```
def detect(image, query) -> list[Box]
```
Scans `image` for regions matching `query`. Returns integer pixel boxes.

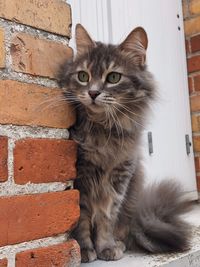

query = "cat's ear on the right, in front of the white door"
[119,27,148,65]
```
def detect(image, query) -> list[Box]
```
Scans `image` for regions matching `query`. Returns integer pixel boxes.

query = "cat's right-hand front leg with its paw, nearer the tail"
[95,162,133,260]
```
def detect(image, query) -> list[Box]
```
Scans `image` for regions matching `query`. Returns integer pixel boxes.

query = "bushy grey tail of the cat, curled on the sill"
[132,181,191,253]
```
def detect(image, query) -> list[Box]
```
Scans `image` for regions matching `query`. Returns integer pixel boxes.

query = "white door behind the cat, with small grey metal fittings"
[68,0,197,199]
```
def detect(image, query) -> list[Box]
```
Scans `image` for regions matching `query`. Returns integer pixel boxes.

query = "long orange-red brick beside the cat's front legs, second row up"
[0,190,79,246]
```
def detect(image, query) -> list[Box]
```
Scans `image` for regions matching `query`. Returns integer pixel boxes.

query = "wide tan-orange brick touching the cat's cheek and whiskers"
[0,80,75,128]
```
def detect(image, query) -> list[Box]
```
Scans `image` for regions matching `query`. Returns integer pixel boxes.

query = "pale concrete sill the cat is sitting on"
[81,204,200,267]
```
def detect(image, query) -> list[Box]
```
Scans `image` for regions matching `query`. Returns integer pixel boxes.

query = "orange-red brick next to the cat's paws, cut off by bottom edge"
[15,240,80,267]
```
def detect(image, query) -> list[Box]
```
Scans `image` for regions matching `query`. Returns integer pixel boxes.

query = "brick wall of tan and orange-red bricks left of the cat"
[0,0,80,267]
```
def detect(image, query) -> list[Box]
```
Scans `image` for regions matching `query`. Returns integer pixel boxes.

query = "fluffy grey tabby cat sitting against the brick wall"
[59,24,190,262]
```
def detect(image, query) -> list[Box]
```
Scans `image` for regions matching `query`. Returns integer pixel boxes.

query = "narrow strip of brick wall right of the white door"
[183,0,200,192]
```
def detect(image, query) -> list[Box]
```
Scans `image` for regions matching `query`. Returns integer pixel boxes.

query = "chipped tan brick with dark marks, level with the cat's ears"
[11,33,72,78]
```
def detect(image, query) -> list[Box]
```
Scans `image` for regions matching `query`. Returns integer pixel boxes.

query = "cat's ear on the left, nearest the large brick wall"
[76,24,95,54]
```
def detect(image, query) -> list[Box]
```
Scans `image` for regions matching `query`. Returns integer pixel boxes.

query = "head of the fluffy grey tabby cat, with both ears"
[58,24,154,124]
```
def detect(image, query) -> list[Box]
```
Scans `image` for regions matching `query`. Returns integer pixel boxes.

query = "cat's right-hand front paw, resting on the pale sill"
[97,246,124,261]
